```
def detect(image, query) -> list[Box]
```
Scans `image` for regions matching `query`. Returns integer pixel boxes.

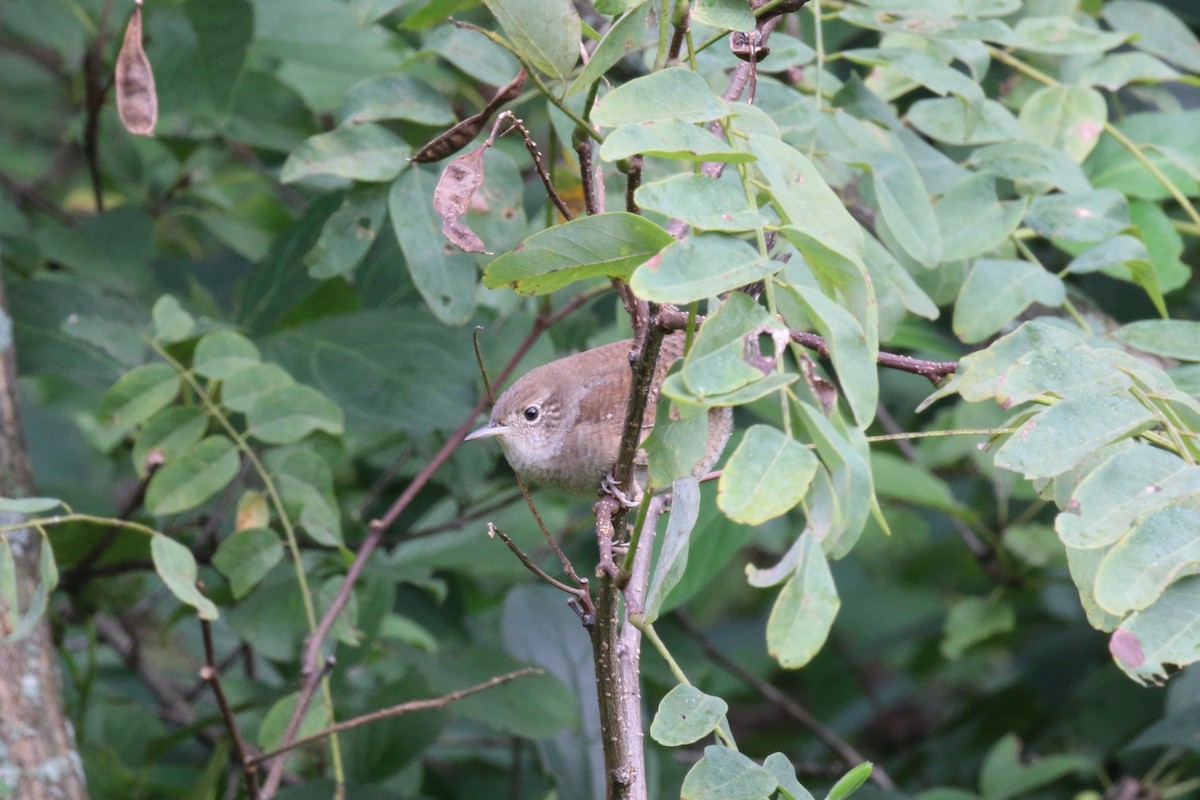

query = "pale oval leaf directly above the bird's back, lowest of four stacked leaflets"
[629,234,782,306]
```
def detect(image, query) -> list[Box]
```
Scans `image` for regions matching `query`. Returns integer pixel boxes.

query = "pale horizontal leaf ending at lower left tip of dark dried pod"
[280,122,413,184]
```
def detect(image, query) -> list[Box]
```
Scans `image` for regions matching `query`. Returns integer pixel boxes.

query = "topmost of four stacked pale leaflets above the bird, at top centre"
[592,67,731,128]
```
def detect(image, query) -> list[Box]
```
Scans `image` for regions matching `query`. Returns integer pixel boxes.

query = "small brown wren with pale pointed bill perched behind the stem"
[467,333,732,494]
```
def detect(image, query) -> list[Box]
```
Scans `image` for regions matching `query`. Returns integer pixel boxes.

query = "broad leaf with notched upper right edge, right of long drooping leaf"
[934,173,1027,261]
